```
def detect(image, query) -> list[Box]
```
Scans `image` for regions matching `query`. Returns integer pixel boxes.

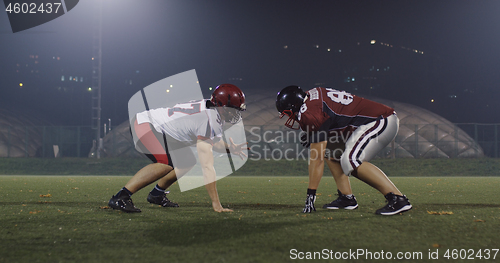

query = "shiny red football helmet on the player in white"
[210,84,246,124]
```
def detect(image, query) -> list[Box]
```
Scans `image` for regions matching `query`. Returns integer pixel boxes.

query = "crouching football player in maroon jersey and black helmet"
[276,86,412,215]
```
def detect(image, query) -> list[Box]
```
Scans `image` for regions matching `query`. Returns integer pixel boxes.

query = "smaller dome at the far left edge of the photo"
[0,109,48,157]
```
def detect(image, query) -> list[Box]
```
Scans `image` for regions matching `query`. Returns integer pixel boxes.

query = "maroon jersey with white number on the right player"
[298,88,394,131]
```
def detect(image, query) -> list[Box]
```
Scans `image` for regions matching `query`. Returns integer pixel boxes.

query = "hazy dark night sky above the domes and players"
[0,0,500,125]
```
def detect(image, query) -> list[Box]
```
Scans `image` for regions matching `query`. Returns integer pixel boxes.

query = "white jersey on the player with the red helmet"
[137,100,223,145]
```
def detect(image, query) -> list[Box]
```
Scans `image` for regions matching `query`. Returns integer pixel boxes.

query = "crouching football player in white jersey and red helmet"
[108,84,247,212]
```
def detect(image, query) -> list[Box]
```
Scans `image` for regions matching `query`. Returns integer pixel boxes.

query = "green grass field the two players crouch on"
[0,176,500,262]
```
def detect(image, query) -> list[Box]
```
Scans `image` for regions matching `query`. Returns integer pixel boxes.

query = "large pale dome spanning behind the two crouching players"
[100,93,484,158]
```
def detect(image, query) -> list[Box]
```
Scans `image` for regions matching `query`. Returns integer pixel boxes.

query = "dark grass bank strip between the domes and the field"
[0,158,500,177]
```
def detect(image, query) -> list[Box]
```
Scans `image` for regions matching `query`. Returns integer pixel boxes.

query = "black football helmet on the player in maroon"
[276,86,306,130]
